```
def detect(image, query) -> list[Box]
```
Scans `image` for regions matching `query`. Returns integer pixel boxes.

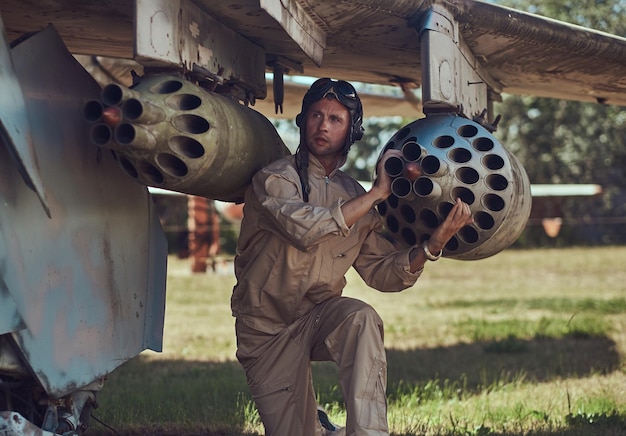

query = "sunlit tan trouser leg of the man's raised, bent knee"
[312,297,389,436]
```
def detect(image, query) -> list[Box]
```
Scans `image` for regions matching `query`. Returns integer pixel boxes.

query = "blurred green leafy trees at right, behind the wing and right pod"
[496,0,626,244]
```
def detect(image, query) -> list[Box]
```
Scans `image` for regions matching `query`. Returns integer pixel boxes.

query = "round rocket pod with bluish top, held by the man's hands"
[378,114,532,260]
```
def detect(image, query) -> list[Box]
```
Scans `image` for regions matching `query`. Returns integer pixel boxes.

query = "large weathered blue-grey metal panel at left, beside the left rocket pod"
[0,28,167,397]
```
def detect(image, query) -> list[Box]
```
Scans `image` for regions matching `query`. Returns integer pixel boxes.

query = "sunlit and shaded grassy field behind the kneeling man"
[89,247,626,436]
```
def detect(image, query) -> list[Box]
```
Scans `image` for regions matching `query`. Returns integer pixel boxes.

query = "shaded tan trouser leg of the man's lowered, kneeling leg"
[236,322,322,436]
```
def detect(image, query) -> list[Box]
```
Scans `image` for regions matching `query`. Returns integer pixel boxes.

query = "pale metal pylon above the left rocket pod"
[135,0,267,101]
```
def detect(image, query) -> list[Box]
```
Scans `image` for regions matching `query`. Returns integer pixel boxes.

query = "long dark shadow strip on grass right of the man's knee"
[387,336,620,392]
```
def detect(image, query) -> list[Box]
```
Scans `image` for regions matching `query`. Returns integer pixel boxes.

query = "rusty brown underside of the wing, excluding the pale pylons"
[0,0,626,105]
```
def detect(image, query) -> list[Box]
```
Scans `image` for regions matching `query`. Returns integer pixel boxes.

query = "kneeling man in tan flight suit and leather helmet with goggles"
[232,79,472,436]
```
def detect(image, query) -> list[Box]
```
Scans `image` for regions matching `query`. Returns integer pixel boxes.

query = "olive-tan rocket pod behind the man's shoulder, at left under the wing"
[83,74,290,202]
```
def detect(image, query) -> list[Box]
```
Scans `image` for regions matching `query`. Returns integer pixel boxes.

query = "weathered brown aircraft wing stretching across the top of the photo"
[0,0,626,115]
